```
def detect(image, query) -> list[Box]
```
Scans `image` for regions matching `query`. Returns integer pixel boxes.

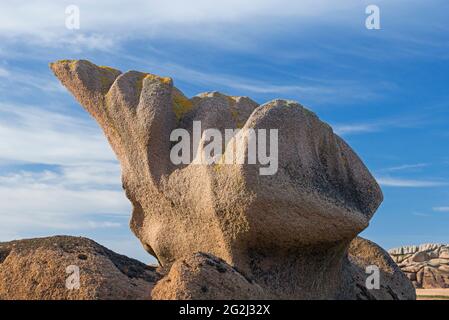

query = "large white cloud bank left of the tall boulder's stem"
[0,104,131,234]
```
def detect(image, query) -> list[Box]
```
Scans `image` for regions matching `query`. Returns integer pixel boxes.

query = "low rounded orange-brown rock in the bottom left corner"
[0,236,160,300]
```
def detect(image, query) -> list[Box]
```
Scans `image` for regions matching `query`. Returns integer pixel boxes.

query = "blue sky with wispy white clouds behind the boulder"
[0,0,449,261]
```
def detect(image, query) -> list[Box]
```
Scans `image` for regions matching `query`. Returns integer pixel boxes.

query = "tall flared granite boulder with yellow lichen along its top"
[51,60,414,299]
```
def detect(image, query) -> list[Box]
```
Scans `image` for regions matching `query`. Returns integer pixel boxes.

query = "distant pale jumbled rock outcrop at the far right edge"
[388,244,449,289]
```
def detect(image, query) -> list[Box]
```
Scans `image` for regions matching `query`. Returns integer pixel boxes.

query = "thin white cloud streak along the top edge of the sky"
[0,0,355,34]
